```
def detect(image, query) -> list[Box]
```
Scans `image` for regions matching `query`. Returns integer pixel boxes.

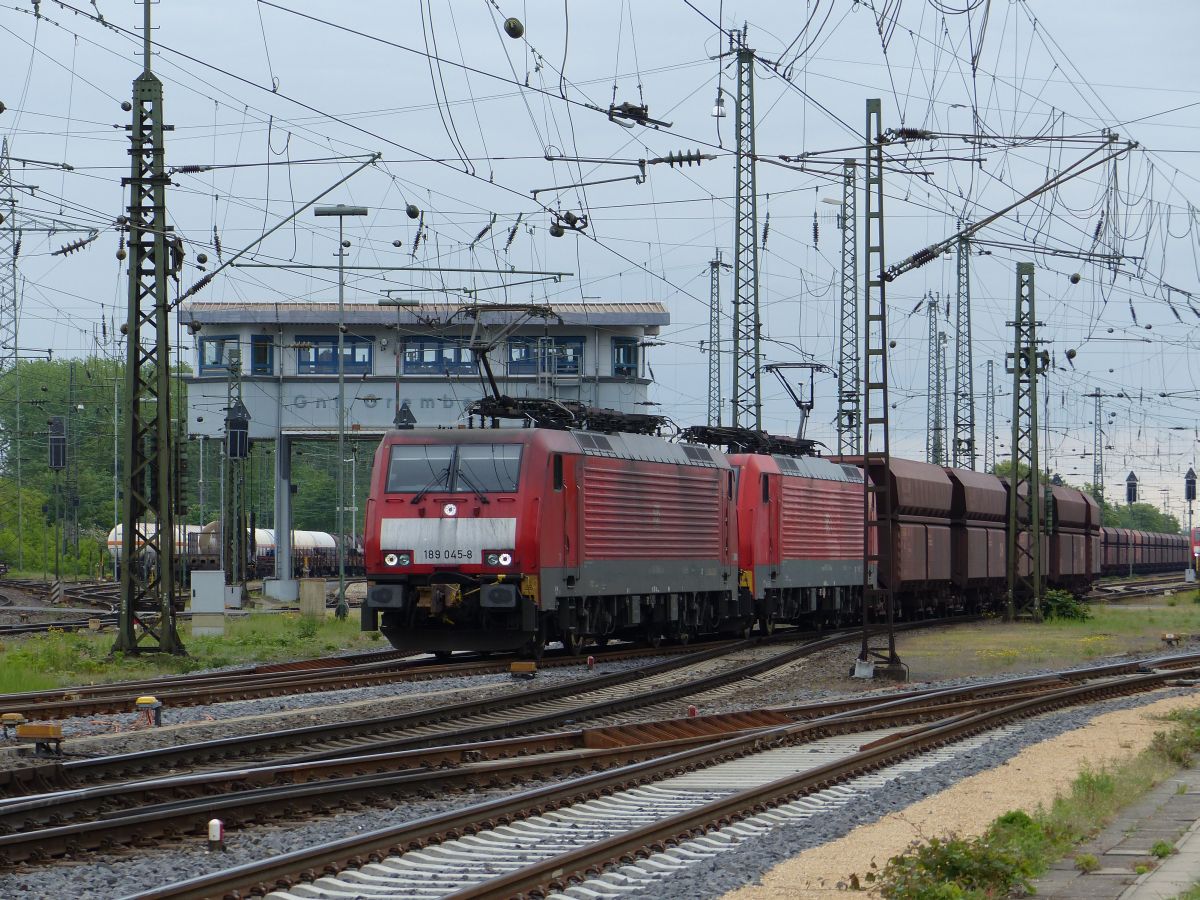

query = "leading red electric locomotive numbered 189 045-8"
[362,428,754,655]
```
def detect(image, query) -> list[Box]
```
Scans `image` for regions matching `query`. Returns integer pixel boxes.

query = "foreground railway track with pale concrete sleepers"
[124,656,1200,900]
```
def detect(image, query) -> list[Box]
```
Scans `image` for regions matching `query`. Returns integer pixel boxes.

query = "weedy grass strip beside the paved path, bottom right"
[851,709,1200,900]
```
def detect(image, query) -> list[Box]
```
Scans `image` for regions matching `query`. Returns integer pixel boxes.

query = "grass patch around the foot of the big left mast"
[0,613,378,694]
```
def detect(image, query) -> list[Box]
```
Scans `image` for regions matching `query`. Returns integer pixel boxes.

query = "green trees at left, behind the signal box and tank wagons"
[0,356,374,576]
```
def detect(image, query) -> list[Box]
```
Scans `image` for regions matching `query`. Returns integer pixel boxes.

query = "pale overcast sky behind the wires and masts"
[0,0,1200,512]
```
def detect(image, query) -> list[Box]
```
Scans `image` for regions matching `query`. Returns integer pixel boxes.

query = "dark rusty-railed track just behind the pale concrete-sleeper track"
[0,677,1080,864]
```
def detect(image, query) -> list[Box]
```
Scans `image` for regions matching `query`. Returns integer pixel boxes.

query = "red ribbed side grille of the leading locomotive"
[582,466,722,559]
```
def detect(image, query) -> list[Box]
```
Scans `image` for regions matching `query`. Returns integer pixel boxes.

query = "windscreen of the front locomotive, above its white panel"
[386,444,521,493]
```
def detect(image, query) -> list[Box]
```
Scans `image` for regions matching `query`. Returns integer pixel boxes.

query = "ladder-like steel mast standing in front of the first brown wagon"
[858,98,901,673]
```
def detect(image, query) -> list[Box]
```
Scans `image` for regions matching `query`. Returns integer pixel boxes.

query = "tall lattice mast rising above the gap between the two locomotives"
[731,30,762,430]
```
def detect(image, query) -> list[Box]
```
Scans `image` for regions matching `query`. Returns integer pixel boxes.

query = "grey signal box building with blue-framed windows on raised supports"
[180,301,670,599]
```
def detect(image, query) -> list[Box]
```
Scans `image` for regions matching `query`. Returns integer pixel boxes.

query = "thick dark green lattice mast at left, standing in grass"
[113,0,184,653]
